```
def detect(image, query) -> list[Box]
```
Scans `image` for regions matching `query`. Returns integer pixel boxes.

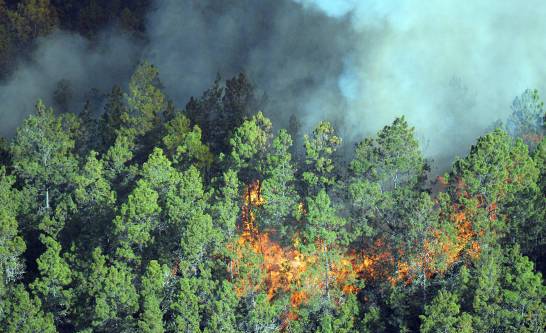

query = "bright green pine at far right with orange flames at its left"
[451,129,542,248]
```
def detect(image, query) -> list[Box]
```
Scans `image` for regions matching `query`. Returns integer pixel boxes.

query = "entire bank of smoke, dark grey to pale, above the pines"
[0,0,546,166]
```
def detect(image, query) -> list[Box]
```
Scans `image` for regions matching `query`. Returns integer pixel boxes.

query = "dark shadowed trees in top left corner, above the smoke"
[0,0,150,78]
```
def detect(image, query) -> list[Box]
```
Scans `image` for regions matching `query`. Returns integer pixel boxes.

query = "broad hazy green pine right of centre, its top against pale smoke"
[348,117,428,260]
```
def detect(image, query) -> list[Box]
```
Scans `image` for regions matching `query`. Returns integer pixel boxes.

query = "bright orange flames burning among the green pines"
[231,180,484,312]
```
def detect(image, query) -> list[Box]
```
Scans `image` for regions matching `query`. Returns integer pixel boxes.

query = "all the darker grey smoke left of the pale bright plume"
[0,0,356,134]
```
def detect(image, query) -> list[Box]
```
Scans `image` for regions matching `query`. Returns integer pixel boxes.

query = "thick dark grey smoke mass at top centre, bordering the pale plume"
[146,0,356,128]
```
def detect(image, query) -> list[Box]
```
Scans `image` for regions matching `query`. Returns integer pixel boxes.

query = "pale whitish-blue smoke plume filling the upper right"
[296,0,546,164]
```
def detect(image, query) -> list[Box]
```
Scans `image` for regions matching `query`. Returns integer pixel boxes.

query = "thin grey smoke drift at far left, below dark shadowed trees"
[0,31,139,135]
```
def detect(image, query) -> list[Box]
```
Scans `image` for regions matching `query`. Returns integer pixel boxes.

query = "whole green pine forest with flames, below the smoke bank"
[0,61,546,333]
